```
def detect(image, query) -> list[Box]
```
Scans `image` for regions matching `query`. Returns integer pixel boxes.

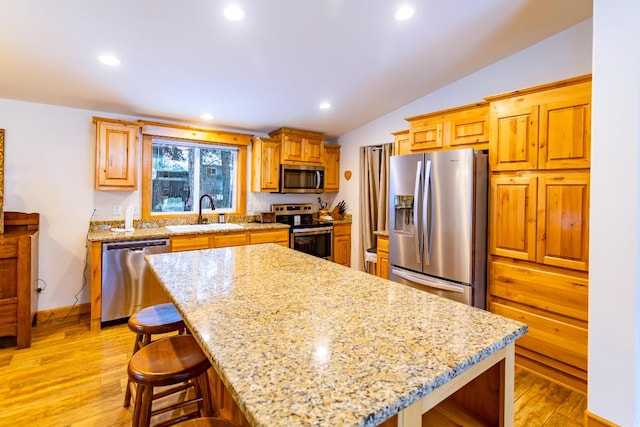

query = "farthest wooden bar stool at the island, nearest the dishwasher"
[123,303,185,408]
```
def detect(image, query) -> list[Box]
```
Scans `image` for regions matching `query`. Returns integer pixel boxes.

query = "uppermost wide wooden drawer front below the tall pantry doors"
[489,260,589,322]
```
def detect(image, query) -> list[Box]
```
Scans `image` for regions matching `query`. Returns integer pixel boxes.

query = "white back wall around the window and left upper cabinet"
[0,99,336,310]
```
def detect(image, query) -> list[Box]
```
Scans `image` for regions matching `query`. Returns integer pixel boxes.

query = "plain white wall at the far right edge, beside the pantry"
[588,0,640,426]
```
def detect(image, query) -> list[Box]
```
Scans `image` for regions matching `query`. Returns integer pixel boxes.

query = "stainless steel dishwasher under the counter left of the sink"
[101,239,170,323]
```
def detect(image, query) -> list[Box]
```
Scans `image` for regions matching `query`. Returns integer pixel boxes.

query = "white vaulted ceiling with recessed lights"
[0,0,593,137]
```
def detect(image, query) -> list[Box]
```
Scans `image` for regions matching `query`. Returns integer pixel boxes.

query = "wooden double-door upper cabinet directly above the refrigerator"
[404,102,489,154]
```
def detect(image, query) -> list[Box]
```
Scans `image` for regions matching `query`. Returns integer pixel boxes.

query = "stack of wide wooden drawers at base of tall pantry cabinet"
[488,257,589,393]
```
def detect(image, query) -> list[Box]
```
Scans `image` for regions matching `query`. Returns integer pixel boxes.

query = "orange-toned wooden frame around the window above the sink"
[141,122,253,220]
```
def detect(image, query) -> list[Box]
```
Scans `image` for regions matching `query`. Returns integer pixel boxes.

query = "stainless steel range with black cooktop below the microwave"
[271,203,333,261]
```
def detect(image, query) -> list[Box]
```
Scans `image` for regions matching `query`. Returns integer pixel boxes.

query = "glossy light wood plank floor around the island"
[0,316,586,427]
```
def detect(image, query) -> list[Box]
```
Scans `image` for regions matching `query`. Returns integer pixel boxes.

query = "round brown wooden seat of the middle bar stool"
[129,335,211,387]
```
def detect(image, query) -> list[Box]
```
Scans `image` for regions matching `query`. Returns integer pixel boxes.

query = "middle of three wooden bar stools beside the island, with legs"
[128,335,215,427]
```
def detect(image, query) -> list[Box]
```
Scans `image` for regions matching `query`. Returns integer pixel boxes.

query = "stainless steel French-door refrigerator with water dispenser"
[389,149,487,309]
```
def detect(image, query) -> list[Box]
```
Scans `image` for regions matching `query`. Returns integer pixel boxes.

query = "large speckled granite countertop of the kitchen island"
[146,244,527,426]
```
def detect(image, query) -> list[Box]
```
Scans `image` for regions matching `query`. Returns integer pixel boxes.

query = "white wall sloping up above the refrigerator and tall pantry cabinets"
[338,20,592,268]
